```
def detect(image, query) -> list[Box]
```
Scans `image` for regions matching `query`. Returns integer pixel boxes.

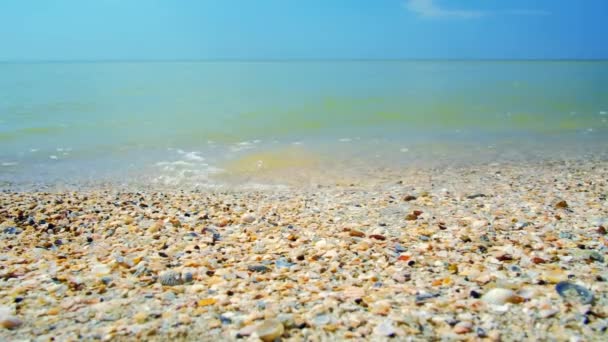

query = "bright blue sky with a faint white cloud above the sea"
[0,0,608,61]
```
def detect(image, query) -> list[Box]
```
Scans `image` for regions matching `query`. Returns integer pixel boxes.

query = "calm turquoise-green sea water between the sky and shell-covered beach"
[0,61,608,185]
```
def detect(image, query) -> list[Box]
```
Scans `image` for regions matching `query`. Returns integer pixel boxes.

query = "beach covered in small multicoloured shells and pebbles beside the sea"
[0,160,608,341]
